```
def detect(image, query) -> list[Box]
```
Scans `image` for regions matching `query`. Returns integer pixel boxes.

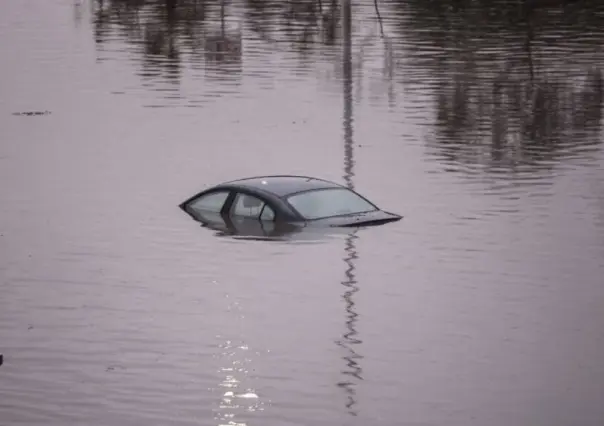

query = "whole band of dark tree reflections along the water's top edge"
[89,0,604,173]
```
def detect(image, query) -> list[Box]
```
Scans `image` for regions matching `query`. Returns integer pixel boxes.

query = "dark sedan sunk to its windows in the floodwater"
[179,175,402,236]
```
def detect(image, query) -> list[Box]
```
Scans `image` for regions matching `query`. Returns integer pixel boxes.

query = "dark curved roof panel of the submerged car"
[221,175,345,197]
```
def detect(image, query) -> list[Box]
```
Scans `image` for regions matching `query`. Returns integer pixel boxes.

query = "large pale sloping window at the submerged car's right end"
[287,188,377,219]
